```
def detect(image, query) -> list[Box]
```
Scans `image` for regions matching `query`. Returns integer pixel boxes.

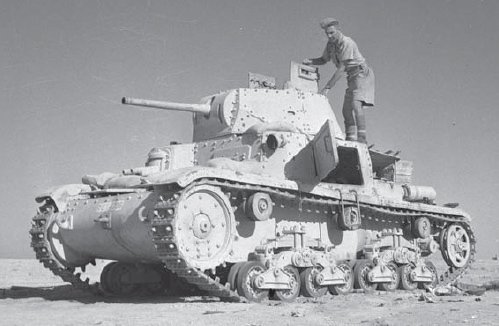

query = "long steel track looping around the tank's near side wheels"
[152,179,476,301]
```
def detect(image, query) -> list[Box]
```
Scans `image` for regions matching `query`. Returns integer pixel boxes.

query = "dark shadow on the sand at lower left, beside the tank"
[0,285,223,304]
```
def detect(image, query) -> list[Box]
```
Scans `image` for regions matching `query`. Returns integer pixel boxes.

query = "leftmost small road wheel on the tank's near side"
[237,261,269,302]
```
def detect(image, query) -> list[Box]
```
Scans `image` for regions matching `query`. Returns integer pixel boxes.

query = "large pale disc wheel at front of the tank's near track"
[174,185,235,270]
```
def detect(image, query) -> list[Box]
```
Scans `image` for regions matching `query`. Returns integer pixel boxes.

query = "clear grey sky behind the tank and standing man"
[0,0,499,258]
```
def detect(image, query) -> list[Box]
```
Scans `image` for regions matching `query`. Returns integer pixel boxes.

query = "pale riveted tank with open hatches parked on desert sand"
[30,62,476,302]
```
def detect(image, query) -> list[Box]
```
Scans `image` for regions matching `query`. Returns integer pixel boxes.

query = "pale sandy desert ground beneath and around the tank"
[0,259,499,326]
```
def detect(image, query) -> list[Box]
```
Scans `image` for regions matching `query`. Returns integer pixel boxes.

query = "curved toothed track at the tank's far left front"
[29,203,94,290]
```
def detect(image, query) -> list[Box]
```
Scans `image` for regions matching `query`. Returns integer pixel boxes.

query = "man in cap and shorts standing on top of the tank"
[303,18,374,143]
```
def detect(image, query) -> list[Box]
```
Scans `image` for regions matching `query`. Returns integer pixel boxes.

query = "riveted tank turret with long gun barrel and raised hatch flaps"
[122,62,344,142]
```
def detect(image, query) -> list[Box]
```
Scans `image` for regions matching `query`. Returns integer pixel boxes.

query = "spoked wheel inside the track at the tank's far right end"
[440,224,471,268]
